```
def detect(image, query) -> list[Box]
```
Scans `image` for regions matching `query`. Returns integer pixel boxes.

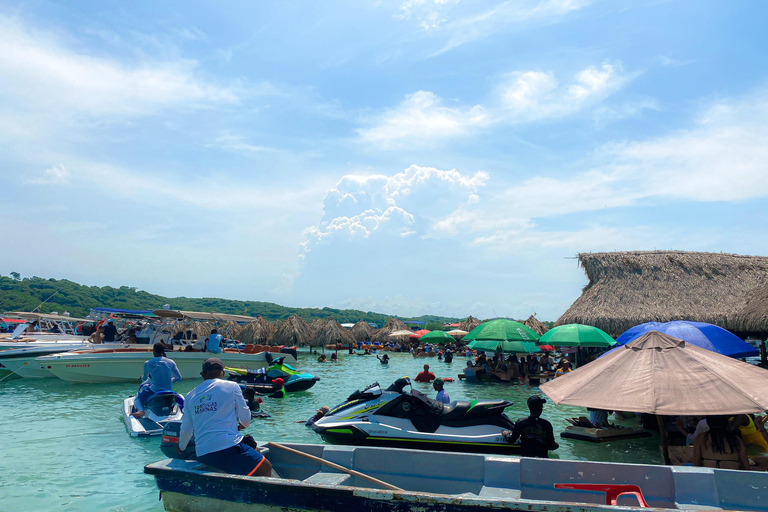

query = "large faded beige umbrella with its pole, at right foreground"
[540,331,768,464]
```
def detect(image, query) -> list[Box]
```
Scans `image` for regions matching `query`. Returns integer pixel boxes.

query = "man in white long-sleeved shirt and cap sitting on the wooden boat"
[179,357,272,476]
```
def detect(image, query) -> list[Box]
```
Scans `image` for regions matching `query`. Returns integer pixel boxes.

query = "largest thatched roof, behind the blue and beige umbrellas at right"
[556,251,768,336]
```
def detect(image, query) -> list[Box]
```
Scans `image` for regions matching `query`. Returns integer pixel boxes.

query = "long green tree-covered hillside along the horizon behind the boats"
[0,272,457,326]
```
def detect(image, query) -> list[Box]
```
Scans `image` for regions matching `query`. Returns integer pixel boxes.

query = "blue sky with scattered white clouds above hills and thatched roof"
[0,0,768,320]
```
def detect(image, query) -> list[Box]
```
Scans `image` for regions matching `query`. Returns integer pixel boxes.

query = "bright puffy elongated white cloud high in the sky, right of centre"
[357,62,637,149]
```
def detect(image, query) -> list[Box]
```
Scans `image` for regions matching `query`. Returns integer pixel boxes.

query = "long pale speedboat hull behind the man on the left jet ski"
[37,346,296,382]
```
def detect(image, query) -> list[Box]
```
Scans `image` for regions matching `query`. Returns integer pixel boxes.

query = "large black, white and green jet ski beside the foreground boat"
[312,377,520,453]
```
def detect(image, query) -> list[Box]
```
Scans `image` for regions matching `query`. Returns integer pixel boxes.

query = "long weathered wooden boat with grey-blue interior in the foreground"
[144,443,768,512]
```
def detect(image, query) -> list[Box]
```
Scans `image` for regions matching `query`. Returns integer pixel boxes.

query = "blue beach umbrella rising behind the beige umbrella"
[616,320,760,359]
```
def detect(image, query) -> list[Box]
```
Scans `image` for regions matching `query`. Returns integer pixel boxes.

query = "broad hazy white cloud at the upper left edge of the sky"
[0,16,238,120]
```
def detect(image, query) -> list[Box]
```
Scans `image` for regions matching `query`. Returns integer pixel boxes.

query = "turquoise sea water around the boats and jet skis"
[0,352,662,512]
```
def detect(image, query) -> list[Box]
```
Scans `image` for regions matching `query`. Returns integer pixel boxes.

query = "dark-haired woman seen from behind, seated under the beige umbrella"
[693,416,749,469]
